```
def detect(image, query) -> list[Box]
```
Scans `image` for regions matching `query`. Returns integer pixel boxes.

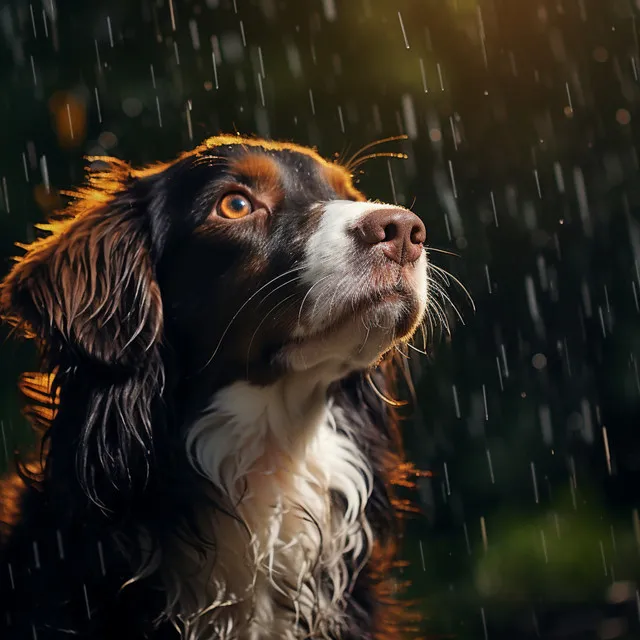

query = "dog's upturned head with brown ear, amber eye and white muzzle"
[0,137,427,502]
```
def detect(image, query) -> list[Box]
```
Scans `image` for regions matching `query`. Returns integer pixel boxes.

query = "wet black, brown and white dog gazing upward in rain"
[0,136,429,640]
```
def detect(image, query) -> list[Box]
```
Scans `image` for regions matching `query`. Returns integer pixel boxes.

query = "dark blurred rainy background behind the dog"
[0,0,640,640]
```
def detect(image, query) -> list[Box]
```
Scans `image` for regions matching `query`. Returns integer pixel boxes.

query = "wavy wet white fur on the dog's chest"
[174,383,372,640]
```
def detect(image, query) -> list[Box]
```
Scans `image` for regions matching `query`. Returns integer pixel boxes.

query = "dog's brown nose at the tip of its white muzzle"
[354,208,427,265]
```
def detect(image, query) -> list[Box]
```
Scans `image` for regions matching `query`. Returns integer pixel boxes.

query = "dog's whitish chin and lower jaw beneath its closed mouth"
[279,294,424,379]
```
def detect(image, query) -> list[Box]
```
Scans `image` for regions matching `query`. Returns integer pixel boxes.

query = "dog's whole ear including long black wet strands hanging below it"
[0,161,164,508]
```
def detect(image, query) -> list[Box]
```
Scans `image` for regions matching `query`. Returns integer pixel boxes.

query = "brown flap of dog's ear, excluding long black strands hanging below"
[0,158,162,369]
